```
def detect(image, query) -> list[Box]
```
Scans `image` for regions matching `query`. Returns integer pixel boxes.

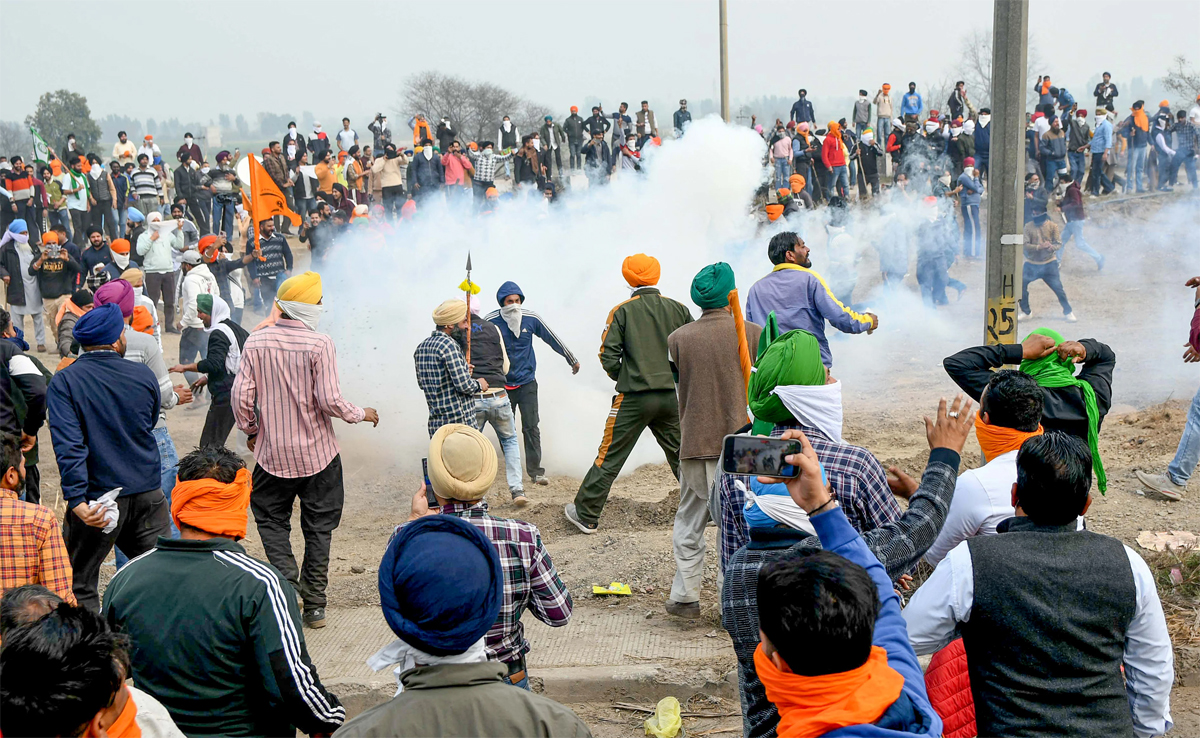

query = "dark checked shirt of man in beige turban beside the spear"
[413,330,480,436]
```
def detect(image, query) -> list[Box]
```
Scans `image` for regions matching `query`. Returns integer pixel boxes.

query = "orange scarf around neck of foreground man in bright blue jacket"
[754,643,904,738]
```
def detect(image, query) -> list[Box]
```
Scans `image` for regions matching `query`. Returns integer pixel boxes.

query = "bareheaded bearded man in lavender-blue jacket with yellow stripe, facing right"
[746,230,880,366]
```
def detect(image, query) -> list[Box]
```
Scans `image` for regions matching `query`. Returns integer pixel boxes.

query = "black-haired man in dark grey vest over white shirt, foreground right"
[904,432,1175,736]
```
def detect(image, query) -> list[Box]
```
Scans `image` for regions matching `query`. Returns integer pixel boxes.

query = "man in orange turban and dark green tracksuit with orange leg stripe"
[564,253,692,535]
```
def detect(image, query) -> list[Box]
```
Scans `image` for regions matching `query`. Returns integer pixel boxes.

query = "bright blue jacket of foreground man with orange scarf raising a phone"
[809,508,942,738]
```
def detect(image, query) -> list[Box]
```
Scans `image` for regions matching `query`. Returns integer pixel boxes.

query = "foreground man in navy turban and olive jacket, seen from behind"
[337,511,592,738]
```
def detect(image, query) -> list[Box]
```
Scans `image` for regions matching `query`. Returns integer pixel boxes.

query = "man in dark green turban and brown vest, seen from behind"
[666,262,762,618]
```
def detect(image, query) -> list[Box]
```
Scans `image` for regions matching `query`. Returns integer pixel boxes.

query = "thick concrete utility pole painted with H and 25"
[983,0,1030,344]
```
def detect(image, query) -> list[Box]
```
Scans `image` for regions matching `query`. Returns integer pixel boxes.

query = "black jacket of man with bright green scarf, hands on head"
[942,338,1117,442]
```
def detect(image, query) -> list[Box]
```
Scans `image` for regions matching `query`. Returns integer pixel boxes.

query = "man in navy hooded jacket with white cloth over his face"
[487,282,580,485]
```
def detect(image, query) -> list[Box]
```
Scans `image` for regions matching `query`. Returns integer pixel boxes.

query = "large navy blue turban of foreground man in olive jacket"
[379,516,504,656]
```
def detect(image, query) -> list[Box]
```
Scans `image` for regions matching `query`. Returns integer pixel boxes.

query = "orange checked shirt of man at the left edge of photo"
[0,490,76,605]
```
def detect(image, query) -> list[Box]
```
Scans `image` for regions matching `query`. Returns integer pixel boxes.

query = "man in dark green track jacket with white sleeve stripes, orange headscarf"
[104,446,346,736]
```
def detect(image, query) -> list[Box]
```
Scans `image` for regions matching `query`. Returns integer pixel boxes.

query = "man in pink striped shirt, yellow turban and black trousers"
[232,272,379,628]
